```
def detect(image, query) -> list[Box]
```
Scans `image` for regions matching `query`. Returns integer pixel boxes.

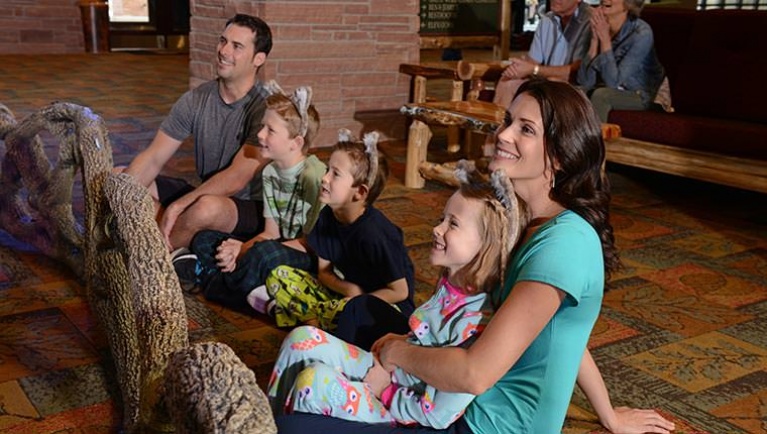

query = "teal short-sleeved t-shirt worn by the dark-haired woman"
[464,211,604,434]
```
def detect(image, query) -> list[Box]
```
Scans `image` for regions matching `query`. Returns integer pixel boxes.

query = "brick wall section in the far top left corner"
[0,0,85,54]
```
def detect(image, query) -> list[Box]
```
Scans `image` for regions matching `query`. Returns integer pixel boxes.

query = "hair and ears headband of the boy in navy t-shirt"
[333,128,389,205]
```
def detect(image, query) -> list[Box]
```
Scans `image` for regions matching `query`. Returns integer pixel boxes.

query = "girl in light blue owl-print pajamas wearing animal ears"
[268,164,526,428]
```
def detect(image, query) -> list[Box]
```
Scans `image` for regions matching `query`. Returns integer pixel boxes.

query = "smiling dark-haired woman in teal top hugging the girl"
[277,80,673,434]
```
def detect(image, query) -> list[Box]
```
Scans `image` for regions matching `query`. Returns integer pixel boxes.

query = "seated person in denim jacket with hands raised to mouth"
[576,0,664,122]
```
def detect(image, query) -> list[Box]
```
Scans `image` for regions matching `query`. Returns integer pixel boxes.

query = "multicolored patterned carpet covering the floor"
[0,53,767,434]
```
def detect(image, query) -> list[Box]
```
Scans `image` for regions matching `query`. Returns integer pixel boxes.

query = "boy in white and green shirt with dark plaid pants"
[173,82,325,310]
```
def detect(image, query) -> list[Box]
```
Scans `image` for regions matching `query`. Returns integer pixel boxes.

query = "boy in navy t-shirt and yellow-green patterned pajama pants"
[248,130,415,333]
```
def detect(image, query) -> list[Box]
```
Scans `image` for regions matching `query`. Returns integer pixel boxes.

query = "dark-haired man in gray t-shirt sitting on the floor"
[125,14,272,250]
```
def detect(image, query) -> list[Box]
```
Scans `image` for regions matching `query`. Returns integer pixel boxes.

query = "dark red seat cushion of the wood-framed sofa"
[608,109,767,161]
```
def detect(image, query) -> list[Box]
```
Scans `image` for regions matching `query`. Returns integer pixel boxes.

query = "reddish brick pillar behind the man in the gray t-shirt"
[190,0,419,146]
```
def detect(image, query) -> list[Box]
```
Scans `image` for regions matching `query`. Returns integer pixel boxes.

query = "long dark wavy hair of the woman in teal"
[515,79,620,280]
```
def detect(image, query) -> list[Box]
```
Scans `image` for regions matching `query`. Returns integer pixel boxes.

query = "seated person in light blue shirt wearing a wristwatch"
[488,0,591,110]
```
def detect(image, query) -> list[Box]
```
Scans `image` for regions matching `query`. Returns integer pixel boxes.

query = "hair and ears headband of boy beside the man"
[266,80,320,154]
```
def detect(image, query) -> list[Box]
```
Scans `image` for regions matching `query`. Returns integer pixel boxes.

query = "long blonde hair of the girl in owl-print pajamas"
[451,160,529,293]
